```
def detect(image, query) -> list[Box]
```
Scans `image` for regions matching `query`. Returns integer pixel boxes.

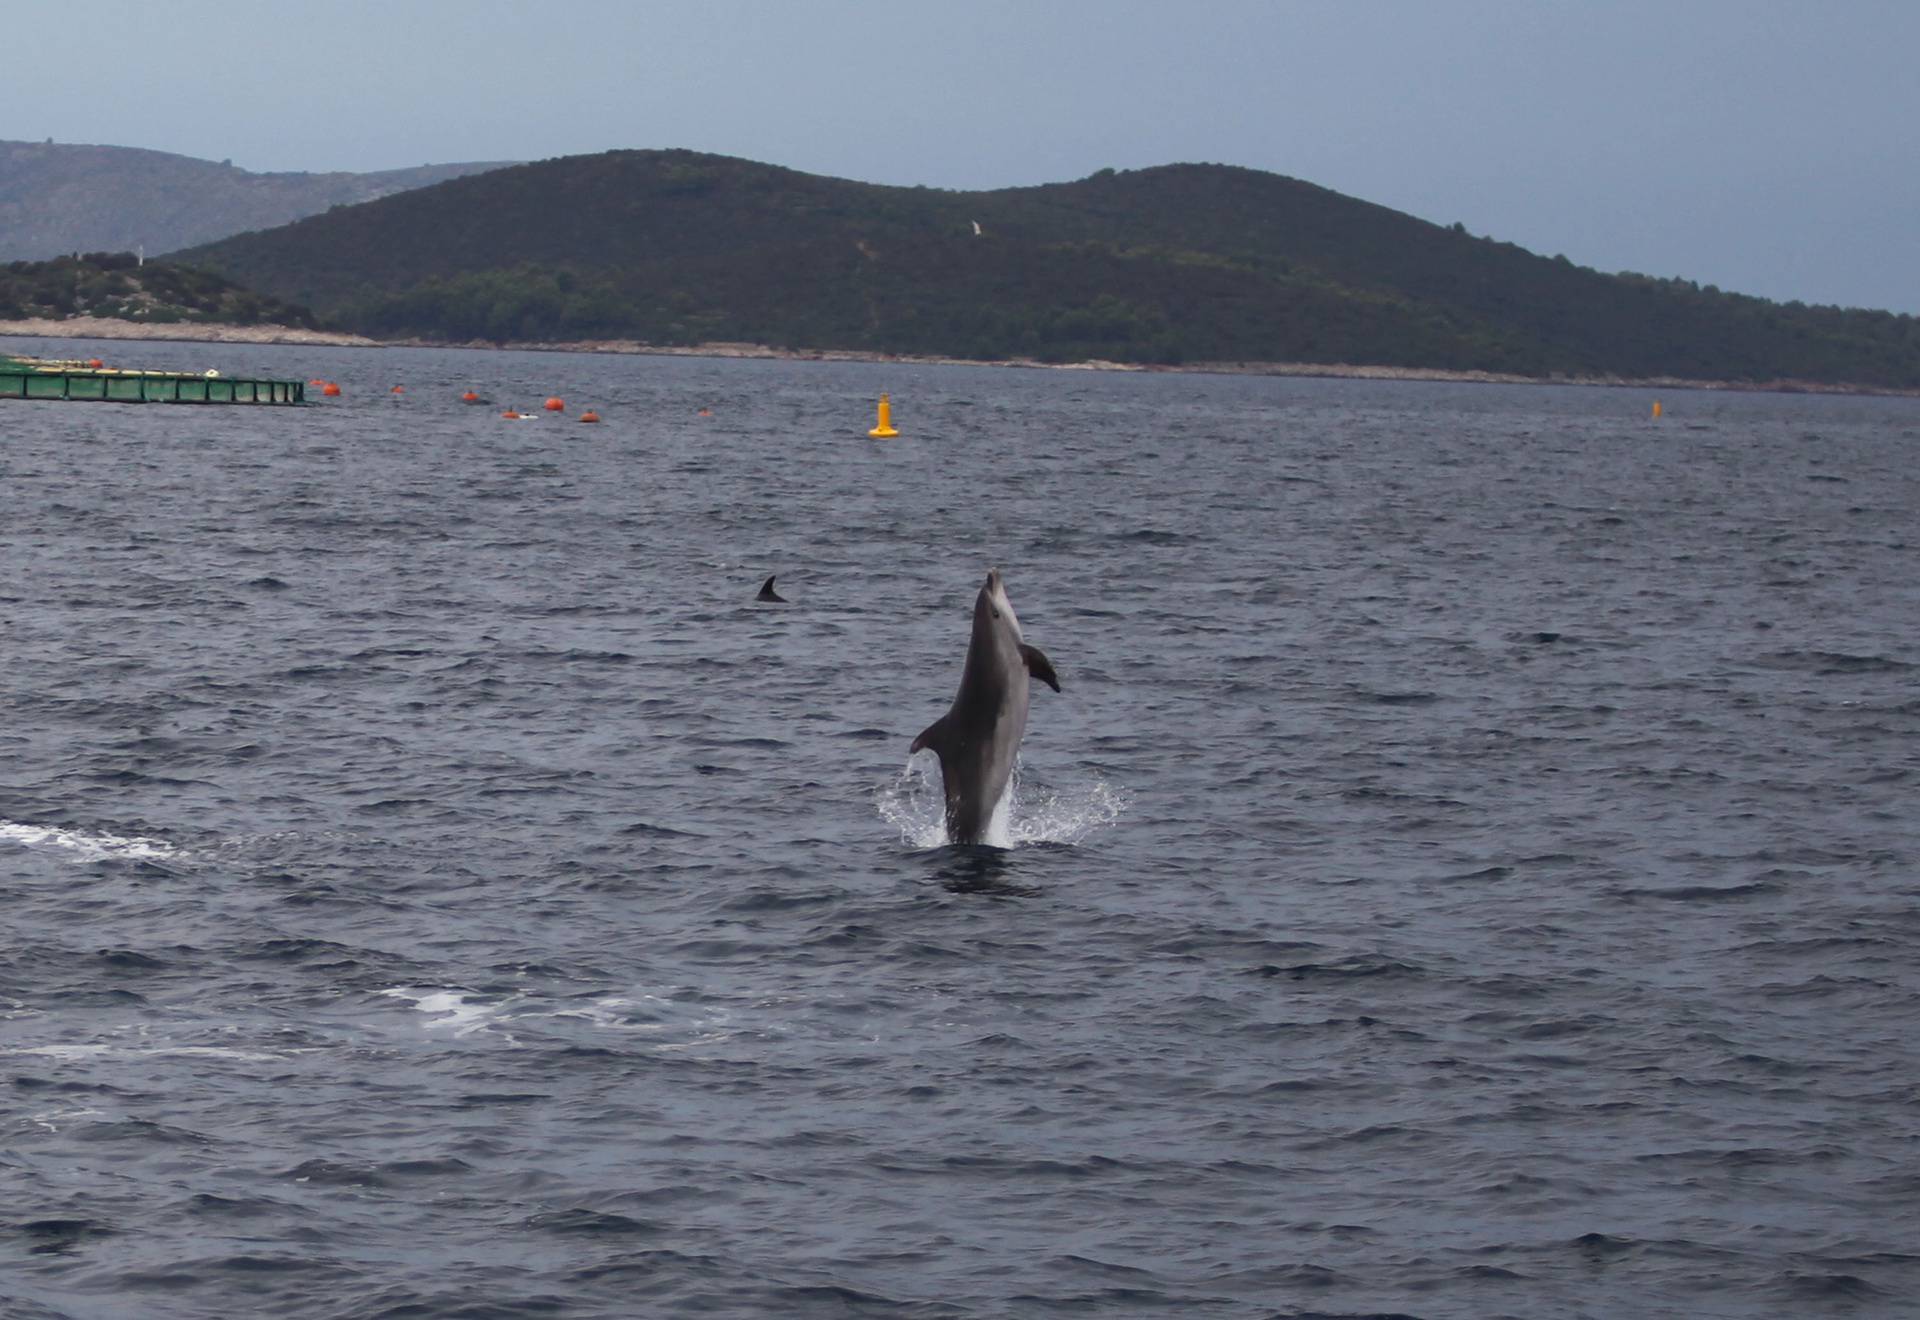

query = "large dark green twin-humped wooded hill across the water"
[175,152,1920,388]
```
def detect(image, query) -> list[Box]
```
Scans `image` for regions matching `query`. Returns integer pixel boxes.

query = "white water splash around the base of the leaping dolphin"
[874,752,1129,850]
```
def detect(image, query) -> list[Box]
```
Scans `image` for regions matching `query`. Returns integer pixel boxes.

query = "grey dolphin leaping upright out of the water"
[912,568,1060,844]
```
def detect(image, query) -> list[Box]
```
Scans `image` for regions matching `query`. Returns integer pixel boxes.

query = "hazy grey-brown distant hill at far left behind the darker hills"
[0,142,518,261]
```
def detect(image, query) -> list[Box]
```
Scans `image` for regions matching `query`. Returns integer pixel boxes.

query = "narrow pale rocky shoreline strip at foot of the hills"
[0,317,1920,399]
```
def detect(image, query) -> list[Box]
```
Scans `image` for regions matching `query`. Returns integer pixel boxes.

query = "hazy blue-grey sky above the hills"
[0,0,1920,313]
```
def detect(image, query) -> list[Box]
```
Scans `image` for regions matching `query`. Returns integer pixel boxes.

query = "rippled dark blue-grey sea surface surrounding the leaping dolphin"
[0,340,1920,1320]
